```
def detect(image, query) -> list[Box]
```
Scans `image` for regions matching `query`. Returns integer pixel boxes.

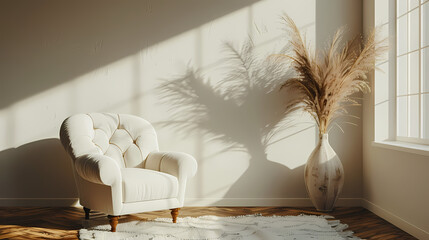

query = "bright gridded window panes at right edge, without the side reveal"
[396,0,429,143]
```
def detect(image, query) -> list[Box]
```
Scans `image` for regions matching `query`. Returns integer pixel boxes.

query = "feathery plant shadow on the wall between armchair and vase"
[159,40,313,198]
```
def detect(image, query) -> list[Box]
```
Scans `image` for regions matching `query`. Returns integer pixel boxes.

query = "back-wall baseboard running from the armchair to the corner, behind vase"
[185,198,361,207]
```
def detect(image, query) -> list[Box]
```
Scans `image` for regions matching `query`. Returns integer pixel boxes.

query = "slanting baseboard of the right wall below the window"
[362,199,429,239]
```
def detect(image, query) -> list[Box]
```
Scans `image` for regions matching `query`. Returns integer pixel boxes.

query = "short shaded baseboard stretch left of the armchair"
[0,198,79,207]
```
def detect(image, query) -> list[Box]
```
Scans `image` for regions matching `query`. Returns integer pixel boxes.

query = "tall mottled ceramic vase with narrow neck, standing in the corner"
[304,134,344,212]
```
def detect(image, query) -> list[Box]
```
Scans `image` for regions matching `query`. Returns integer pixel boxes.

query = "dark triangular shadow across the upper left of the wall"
[0,0,258,109]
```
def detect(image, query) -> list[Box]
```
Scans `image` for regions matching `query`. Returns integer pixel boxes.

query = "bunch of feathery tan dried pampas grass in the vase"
[275,16,387,135]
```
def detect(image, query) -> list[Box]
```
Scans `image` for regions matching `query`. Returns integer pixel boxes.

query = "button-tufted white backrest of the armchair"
[60,113,158,168]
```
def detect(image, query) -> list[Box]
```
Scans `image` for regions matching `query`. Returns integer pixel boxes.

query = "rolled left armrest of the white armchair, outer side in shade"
[74,154,121,186]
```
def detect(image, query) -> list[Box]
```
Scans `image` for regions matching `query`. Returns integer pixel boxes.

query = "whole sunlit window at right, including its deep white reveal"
[374,0,429,145]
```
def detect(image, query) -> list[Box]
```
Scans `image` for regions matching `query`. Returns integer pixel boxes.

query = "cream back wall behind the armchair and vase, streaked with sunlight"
[0,0,362,206]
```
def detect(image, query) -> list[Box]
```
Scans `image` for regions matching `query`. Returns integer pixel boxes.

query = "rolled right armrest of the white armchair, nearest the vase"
[145,152,197,179]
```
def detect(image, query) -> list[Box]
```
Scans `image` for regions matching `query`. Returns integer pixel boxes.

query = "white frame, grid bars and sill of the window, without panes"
[373,0,429,148]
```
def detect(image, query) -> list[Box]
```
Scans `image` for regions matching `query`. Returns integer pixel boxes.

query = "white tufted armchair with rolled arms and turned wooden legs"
[60,113,197,232]
